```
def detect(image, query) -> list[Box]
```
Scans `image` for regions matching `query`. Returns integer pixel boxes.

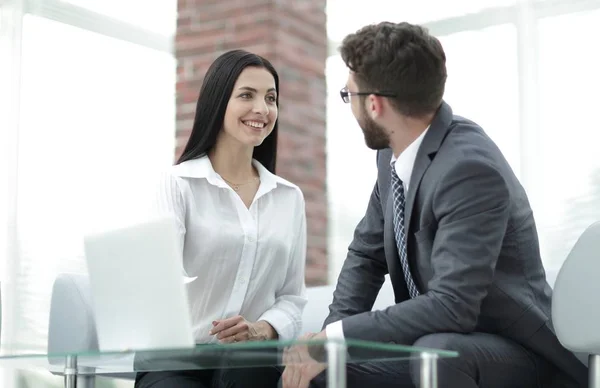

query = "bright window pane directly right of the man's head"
[439,24,520,176]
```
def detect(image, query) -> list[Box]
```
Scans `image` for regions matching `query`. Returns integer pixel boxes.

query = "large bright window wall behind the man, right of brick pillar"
[327,0,600,279]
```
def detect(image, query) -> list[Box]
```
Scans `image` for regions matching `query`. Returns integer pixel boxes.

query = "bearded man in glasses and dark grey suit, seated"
[282,23,587,388]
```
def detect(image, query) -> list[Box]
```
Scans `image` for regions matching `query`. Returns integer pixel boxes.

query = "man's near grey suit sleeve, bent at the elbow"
[342,160,510,345]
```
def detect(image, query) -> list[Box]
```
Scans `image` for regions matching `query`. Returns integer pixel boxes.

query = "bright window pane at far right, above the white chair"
[536,10,600,268]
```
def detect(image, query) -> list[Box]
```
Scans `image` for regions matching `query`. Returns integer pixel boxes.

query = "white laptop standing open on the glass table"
[84,217,195,351]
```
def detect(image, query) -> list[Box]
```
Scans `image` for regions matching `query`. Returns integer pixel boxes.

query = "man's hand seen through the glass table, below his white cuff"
[281,331,327,388]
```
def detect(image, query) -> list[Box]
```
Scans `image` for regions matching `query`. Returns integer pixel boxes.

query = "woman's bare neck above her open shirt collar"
[208,138,258,183]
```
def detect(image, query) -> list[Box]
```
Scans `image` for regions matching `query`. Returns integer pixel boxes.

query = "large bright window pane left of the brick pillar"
[14,15,175,345]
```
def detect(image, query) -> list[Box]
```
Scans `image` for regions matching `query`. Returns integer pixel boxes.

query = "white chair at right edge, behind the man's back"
[552,222,600,388]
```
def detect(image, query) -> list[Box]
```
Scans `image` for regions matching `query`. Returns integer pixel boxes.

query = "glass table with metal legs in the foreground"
[0,340,458,388]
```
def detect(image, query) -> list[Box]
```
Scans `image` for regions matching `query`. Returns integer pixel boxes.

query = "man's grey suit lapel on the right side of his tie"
[404,102,453,233]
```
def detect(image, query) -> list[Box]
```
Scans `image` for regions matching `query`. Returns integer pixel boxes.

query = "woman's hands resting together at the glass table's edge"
[208,315,277,344]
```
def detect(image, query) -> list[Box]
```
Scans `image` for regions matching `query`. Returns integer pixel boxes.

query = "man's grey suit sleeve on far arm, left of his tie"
[323,153,387,327]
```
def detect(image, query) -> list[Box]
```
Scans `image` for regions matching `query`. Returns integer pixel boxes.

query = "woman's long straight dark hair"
[177,50,279,174]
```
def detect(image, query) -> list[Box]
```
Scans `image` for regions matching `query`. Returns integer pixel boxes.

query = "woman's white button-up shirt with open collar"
[155,157,306,343]
